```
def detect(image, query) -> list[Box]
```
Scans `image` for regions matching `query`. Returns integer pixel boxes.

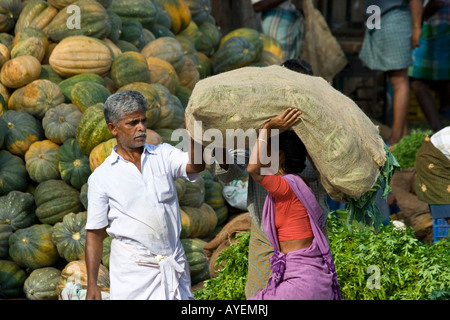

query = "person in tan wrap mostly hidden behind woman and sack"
[211,59,329,298]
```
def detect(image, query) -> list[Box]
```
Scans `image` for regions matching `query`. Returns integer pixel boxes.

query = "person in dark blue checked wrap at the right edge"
[408,0,450,132]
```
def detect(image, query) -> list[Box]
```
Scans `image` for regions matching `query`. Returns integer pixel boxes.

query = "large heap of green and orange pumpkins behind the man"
[0,0,282,299]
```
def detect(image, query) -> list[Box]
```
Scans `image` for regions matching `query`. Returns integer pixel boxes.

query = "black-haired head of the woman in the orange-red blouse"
[272,130,308,174]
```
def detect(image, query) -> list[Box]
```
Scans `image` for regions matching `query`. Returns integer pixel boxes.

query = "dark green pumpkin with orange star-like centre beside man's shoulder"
[58,138,91,189]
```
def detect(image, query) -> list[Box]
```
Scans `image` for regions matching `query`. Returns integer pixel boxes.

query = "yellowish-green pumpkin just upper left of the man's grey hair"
[70,81,111,113]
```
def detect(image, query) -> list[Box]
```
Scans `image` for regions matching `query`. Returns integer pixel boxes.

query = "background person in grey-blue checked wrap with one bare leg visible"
[359,0,422,145]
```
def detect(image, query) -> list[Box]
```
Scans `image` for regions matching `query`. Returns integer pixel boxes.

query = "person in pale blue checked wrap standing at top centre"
[252,0,305,59]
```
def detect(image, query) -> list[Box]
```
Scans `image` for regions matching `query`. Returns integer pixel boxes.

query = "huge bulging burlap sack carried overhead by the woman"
[185,65,386,201]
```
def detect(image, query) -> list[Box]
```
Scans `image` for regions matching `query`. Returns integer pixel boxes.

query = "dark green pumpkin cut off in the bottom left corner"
[0,260,27,299]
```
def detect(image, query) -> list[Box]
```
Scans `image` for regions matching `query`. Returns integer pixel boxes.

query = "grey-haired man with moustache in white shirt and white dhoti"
[86,90,205,300]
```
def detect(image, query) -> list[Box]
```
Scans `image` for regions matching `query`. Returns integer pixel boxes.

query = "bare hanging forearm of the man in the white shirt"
[85,228,106,300]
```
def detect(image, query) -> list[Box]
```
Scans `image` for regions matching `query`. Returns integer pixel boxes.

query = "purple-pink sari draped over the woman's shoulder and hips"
[249,174,341,300]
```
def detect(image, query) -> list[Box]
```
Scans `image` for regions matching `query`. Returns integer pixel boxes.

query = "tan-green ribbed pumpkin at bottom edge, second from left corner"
[23,267,61,300]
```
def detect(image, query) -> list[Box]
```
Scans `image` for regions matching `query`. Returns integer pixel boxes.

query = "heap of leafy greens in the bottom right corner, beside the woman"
[328,214,450,300]
